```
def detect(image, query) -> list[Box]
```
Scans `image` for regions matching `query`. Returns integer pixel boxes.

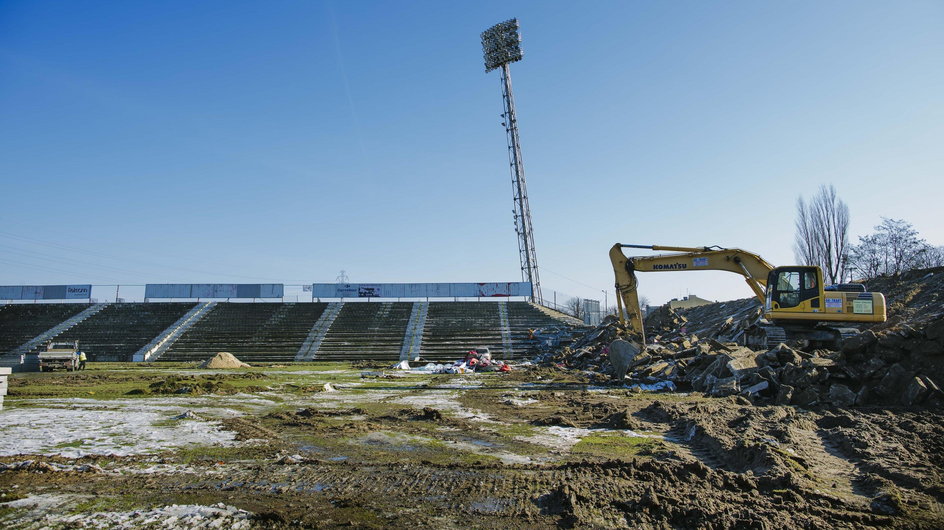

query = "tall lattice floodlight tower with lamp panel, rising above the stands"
[482,18,544,304]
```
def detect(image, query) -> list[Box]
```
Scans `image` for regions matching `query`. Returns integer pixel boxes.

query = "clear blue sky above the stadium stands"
[0,0,944,303]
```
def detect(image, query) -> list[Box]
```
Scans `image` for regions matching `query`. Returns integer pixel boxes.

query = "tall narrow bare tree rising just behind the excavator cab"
[793,186,849,283]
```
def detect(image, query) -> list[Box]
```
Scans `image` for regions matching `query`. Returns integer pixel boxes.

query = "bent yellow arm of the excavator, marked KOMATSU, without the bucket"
[610,243,774,344]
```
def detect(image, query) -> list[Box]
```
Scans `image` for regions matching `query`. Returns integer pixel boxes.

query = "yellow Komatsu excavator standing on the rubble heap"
[610,243,885,349]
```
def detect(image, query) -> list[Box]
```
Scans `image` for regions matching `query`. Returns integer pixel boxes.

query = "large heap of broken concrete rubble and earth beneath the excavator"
[538,269,944,407]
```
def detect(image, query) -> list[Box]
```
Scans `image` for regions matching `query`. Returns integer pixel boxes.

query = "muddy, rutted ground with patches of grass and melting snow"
[0,364,944,528]
